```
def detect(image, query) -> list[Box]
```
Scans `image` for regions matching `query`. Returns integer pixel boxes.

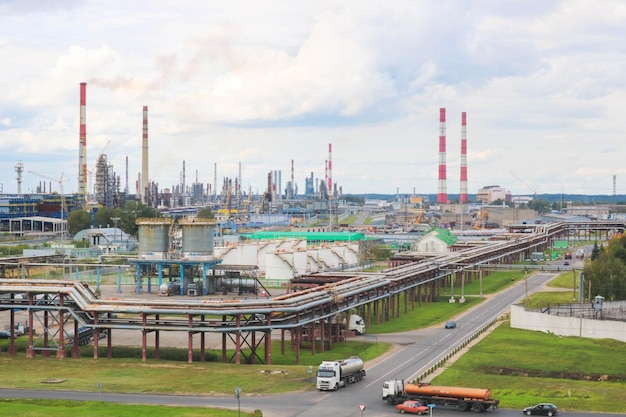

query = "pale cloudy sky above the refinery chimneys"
[0,0,626,195]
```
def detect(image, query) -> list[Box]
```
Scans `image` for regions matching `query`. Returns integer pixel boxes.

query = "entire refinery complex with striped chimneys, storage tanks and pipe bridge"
[0,83,626,364]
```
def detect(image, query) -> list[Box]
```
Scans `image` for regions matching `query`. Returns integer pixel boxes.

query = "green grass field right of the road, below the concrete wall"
[431,322,626,413]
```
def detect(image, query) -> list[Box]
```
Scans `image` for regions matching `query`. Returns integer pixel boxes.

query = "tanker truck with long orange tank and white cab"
[383,379,500,413]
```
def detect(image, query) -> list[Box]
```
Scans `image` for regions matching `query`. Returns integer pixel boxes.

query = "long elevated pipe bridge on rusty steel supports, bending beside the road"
[0,222,625,364]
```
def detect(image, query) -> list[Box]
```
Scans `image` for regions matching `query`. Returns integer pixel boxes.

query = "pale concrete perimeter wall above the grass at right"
[511,305,626,342]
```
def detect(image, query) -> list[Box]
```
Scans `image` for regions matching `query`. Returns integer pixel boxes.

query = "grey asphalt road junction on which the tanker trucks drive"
[0,273,623,417]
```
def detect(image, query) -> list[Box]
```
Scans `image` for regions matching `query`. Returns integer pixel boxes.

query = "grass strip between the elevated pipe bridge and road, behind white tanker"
[0,340,382,395]
